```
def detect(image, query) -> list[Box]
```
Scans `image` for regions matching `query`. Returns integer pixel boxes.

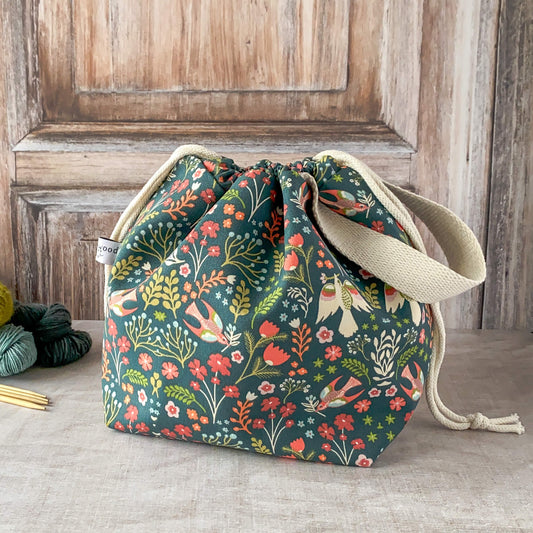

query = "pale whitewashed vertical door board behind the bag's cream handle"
[414,0,499,328]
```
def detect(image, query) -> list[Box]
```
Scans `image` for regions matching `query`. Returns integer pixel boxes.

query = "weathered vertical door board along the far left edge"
[0,0,40,287]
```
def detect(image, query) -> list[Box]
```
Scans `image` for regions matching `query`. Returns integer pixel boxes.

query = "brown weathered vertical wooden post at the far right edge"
[482,0,533,329]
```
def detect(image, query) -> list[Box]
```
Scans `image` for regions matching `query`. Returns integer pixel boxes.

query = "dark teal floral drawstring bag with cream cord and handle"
[102,145,524,467]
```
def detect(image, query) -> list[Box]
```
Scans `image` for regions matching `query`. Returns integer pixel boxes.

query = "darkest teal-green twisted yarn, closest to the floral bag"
[11,302,92,366]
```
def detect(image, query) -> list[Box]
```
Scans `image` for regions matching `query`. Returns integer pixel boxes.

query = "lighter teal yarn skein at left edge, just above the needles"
[0,324,37,377]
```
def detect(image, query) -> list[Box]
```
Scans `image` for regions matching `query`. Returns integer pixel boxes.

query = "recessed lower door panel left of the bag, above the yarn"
[13,188,136,319]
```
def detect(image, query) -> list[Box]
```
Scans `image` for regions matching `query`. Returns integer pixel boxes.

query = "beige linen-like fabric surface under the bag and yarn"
[0,322,533,533]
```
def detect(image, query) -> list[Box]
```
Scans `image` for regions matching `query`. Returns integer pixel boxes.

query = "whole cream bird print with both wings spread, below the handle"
[316,274,372,337]
